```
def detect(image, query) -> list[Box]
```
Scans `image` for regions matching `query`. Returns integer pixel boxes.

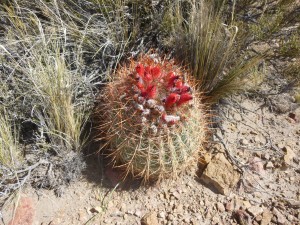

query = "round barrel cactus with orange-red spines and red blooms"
[95,54,206,182]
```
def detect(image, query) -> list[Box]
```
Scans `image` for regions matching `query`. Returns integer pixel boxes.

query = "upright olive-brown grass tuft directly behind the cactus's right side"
[162,1,261,102]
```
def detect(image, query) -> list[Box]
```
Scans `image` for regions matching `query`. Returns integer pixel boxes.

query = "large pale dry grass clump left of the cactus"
[0,0,132,152]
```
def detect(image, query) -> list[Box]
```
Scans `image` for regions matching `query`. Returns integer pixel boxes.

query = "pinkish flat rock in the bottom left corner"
[8,197,35,225]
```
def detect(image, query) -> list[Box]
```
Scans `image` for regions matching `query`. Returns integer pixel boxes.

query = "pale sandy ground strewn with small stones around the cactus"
[2,18,300,225]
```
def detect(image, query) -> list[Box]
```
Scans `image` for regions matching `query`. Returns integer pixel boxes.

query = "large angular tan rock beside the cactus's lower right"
[200,153,241,195]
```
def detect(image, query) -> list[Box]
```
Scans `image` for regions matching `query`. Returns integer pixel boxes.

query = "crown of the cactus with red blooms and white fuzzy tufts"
[120,55,193,134]
